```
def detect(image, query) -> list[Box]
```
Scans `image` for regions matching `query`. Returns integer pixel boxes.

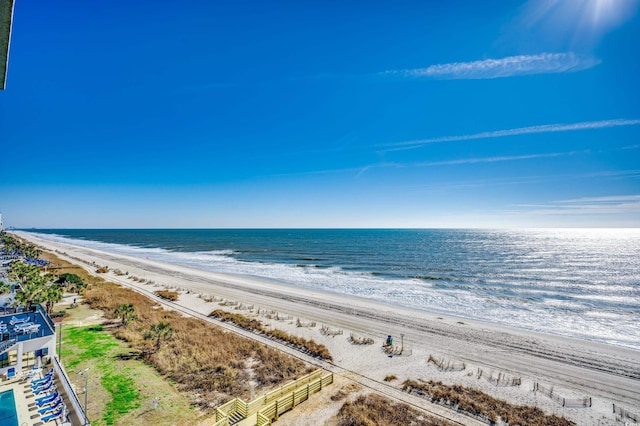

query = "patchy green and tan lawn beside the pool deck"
[61,325,204,425]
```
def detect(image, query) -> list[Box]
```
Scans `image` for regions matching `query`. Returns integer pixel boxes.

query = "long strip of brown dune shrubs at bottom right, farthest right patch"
[402,380,574,426]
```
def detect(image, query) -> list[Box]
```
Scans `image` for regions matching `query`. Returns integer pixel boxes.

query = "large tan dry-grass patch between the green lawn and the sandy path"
[84,282,311,409]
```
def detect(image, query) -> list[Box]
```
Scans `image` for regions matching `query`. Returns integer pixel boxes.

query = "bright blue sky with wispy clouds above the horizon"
[0,0,640,228]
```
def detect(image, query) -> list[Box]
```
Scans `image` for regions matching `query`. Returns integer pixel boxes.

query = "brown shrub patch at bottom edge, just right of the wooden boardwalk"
[337,394,450,426]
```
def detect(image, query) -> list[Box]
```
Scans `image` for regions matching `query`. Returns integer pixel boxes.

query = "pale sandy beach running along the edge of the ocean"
[15,232,640,425]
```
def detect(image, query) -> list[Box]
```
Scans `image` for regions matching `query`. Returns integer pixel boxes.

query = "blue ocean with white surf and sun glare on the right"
[23,229,640,350]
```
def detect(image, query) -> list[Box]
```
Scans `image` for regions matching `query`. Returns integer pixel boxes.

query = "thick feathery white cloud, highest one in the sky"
[381,52,600,80]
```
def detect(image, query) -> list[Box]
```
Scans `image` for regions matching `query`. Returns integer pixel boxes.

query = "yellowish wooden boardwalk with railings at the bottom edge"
[213,370,333,426]
